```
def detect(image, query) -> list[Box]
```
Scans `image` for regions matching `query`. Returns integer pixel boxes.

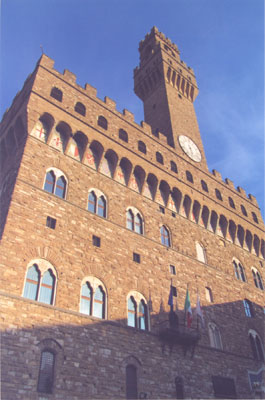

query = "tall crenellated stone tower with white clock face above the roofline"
[134,27,208,170]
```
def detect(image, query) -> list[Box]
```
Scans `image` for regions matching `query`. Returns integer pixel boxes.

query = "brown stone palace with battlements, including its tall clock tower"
[0,28,265,400]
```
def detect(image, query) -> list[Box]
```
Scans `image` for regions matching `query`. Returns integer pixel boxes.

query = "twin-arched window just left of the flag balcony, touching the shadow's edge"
[127,292,149,331]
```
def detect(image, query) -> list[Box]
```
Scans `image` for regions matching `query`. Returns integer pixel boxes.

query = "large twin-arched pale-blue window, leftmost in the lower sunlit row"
[23,260,56,305]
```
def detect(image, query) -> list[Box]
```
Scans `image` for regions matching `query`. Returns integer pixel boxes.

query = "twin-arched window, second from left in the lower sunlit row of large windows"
[80,277,106,319]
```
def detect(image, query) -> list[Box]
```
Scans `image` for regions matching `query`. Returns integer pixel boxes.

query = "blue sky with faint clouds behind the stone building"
[0,0,264,215]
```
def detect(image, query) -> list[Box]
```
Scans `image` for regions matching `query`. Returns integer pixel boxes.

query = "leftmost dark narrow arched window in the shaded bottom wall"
[37,350,55,393]
